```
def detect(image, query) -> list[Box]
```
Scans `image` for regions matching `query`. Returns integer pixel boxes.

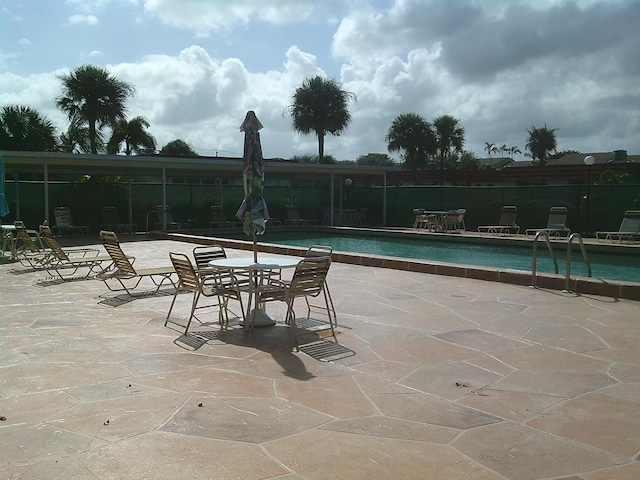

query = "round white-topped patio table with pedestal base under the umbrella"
[209,256,301,329]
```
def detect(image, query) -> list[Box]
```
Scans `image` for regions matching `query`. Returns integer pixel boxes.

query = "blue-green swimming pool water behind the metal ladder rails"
[241,232,640,282]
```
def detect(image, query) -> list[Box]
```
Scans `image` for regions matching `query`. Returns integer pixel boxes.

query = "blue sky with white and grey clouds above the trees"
[0,0,640,161]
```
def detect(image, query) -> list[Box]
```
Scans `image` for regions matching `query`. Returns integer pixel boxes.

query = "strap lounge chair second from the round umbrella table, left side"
[39,225,111,280]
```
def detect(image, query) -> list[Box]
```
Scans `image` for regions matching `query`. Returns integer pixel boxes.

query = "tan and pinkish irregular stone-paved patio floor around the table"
[0,240,640,480]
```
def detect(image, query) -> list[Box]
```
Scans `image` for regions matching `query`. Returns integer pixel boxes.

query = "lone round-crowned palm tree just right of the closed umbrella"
[286,75,356,163]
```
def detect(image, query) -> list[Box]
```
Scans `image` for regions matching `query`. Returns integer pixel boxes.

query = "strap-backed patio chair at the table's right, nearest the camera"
[251,256,337,350]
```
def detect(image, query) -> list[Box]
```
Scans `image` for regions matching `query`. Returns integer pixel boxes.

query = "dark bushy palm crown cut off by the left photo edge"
[0,105,57,152]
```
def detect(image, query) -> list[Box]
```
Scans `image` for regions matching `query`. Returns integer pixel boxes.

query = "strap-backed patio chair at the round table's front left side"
[164,252,244,335]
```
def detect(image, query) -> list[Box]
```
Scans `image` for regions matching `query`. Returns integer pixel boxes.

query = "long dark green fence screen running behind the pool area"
[2,182,640,232]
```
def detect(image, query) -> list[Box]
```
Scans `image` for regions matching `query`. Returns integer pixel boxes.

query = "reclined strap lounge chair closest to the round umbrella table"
[96,230,176,295]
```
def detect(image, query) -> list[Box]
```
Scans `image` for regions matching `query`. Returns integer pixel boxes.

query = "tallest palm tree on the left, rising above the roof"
[56,65,135,153]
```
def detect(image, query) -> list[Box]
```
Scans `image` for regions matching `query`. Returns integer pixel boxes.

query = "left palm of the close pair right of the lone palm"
[385,113,436,185]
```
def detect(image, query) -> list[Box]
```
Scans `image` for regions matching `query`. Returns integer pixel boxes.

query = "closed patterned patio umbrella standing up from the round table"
[236,111,269,263]
